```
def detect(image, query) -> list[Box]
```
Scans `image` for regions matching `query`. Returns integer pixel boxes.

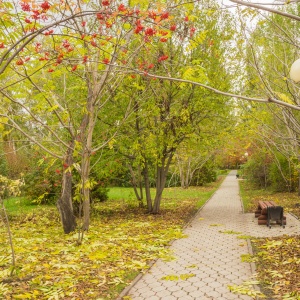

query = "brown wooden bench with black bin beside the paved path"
[255,201,286,228]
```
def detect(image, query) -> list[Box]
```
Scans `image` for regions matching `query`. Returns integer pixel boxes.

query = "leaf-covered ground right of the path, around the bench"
[240,180,300,300]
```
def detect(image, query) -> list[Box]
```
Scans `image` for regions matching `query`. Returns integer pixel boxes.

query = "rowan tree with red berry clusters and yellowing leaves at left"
[0,1,200,233]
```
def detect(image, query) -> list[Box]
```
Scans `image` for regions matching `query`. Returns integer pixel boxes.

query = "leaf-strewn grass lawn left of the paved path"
[0,181,225,300]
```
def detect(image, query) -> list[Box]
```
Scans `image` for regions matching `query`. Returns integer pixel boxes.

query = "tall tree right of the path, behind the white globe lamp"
[233,1,299,192]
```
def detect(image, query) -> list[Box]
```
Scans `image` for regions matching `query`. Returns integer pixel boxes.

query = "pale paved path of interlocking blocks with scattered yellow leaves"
[119,171,300,300]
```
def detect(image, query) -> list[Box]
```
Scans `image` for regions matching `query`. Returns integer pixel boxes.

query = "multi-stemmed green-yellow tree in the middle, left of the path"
[115,2,234,213]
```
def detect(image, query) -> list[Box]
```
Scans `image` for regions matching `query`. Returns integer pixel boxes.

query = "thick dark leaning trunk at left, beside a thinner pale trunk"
[57,149,76,233]
